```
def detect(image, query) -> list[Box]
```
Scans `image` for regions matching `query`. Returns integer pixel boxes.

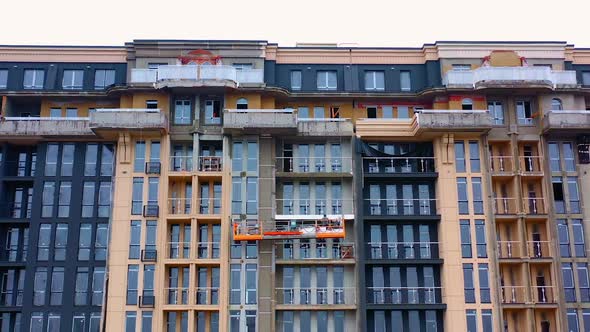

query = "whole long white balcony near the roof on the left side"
[130,65,264,88]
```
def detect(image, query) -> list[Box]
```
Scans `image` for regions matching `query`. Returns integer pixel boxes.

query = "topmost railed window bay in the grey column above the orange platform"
[276,138,352,178]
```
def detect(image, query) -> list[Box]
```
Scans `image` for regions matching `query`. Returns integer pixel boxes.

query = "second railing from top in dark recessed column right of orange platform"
[365,198,437,216]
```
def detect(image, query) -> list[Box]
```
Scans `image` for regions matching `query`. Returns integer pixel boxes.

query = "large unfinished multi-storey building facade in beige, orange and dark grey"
[0,40,590,332]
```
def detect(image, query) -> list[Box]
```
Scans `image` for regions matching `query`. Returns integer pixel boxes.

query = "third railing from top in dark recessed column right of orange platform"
[367,242,438,259]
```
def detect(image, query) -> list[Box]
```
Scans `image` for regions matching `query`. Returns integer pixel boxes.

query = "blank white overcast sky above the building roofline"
[0,0,590,47]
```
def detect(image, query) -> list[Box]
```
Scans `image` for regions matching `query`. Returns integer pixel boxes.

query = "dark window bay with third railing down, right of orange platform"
[365,222,442,264]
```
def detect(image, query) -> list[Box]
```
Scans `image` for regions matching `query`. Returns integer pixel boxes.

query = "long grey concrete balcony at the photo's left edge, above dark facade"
[0,117,95,139]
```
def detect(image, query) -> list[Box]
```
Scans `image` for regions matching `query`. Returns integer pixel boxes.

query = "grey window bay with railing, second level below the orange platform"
[274,264,357,310]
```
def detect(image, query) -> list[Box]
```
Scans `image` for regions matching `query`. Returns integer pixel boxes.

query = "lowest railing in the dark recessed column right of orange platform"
[367,287,442,304]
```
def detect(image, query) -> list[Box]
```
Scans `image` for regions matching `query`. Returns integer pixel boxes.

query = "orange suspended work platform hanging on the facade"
[233,218,346,241]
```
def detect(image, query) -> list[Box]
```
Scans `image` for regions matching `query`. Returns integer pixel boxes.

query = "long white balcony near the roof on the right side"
[443,66,578,89]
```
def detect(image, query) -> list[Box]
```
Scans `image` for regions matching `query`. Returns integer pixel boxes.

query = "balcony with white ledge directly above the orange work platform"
[274,199,354,220]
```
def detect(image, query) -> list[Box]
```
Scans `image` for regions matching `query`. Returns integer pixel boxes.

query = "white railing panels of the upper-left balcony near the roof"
[131,65,264,84]
